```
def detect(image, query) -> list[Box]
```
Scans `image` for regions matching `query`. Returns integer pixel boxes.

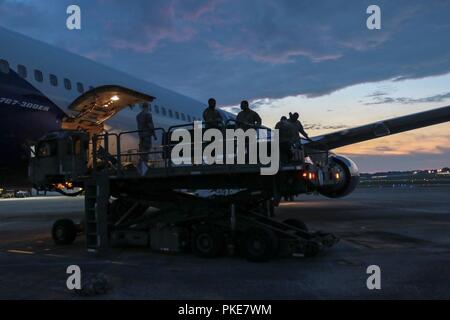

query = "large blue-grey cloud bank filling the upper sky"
[0,0,450,105]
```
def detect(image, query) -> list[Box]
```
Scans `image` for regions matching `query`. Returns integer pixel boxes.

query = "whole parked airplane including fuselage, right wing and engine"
[0,27,450,197]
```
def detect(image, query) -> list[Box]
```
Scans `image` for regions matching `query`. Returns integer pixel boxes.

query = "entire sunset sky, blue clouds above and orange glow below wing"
[0,0,450,172]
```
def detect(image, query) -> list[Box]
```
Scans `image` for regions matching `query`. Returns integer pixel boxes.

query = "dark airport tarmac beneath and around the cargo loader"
[0,186,450,300]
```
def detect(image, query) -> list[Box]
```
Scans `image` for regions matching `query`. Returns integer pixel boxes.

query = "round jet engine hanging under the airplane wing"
[319,154,359,198]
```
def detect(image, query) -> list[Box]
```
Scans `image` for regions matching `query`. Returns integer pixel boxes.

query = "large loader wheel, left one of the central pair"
[191,225,225,258]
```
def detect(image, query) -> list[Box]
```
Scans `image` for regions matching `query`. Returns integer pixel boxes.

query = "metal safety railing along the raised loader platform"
[92,119,324,175]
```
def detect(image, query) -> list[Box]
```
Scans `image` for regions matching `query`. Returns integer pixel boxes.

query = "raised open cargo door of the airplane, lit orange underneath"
[62,85,155,133]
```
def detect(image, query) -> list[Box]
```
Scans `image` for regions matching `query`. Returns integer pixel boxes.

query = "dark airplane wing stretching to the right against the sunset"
[304,106,450,150]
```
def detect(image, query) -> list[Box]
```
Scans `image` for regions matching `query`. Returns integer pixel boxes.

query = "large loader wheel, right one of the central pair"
[243,228,278,262]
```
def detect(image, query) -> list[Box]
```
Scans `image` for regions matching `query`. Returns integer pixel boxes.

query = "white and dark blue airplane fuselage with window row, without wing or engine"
[0,27,235,186]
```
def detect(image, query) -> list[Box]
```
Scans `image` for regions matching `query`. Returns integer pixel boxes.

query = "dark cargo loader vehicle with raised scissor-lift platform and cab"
[30,119,338,262]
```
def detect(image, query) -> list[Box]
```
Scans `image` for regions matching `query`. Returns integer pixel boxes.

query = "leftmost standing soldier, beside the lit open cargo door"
[136,103,156,163]
